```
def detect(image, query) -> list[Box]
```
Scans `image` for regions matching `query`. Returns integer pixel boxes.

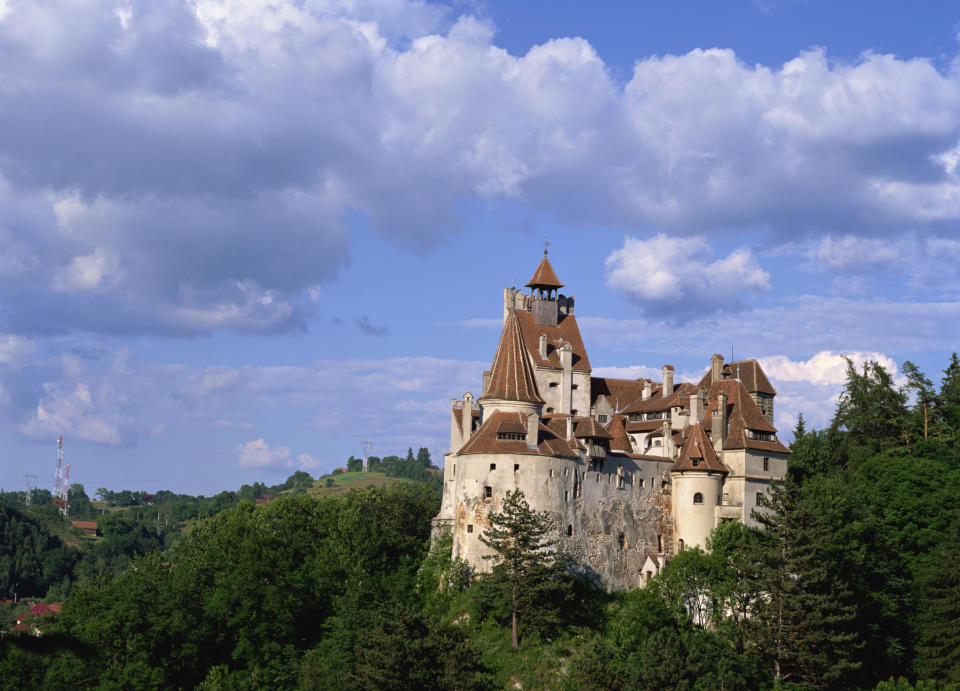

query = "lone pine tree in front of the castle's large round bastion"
[480,490,565,648]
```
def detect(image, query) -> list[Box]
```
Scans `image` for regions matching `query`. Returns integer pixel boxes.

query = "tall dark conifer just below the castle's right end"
[750,480,863,688]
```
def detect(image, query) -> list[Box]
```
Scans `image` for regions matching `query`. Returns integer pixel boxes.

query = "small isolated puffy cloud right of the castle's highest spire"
[605,234,770,321]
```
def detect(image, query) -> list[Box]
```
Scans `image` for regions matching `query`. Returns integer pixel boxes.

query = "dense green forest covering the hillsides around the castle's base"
[0,354,960,691]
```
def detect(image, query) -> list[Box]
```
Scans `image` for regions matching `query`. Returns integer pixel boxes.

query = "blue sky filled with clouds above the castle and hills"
[0,0,960,495]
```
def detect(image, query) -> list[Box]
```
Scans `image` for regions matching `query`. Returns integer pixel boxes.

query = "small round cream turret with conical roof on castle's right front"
[670,423,729,551]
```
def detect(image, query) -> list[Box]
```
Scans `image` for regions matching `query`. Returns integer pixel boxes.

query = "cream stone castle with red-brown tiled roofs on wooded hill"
[434,251,790,588]
